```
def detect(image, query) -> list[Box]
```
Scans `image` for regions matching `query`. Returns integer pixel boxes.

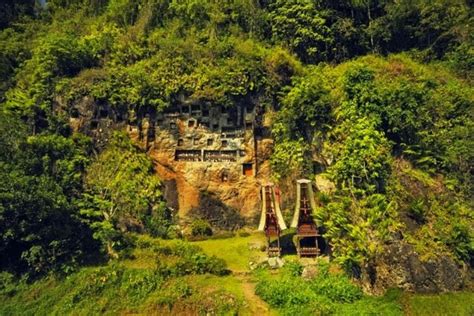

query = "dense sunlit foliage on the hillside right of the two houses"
[272,55,474,268]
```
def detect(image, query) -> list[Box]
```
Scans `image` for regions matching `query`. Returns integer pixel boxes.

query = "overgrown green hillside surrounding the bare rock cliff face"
[0,0,474,314]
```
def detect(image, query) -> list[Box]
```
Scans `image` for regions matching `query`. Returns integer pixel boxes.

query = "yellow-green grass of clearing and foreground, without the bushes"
[0,234,474,316]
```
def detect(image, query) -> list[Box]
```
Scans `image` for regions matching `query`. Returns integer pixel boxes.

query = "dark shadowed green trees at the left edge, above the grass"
[0,112,96,275]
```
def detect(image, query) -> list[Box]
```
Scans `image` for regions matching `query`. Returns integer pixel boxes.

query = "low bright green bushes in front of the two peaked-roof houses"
[256,262,401,315]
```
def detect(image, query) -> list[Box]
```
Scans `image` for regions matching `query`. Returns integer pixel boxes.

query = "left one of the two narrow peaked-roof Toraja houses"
[258,183,286,257]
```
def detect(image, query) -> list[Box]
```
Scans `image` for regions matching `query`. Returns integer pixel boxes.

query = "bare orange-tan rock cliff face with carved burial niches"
[62,97,273,227]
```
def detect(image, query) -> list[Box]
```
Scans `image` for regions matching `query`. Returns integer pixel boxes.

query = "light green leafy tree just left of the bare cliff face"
[81,132,172,258]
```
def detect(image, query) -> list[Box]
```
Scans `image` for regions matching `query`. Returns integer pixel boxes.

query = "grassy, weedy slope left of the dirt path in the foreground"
[0,238,241,315]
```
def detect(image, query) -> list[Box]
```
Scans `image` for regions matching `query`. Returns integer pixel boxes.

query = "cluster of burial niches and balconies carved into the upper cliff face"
[164,103,255,176]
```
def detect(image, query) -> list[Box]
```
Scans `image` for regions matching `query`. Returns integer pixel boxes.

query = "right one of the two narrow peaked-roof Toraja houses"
[291,179,319,257]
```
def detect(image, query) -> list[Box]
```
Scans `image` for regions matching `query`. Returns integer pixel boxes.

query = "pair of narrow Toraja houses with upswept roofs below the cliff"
[258,179,320,257]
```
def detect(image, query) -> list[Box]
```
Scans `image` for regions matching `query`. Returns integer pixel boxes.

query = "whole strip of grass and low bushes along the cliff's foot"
[0,235,473,315]
